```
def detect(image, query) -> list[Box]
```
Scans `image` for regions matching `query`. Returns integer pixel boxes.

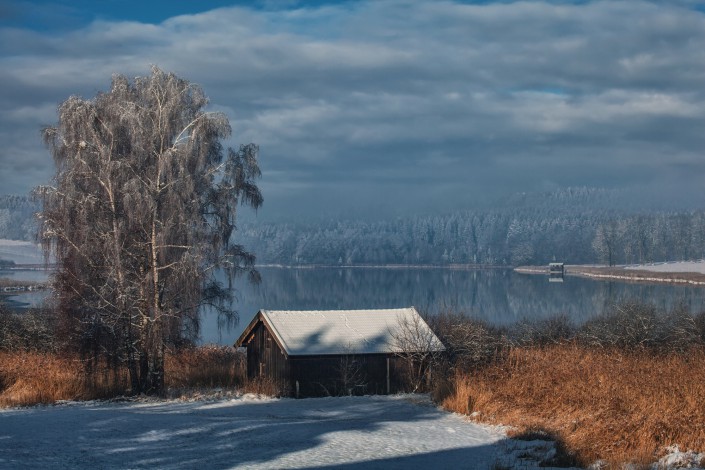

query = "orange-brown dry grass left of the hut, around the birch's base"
[0,347,244,407]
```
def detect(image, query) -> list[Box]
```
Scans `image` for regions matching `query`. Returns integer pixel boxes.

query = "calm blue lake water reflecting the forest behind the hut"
[0,267,705,344]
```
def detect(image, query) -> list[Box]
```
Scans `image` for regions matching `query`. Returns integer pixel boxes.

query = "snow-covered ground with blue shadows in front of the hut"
[0,395,568,469]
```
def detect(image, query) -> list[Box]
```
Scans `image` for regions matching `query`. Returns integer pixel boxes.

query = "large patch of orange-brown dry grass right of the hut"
[442,345,705,467]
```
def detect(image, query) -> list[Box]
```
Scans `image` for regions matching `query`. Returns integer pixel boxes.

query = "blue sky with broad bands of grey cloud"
[0,0,705,220]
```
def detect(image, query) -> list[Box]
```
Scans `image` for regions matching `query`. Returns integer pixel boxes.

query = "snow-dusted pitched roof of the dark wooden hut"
[236,307,444,356]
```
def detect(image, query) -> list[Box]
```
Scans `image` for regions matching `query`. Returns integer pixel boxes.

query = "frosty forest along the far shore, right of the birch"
[237,188,705,265]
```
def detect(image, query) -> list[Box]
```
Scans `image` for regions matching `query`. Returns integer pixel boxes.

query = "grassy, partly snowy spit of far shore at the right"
[514,263,705,286]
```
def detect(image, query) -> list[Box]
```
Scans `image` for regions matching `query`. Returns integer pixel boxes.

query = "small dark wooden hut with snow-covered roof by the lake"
[235,307,445,397]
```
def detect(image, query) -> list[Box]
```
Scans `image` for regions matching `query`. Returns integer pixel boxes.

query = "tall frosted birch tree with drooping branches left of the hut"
[36,67,262,393]
